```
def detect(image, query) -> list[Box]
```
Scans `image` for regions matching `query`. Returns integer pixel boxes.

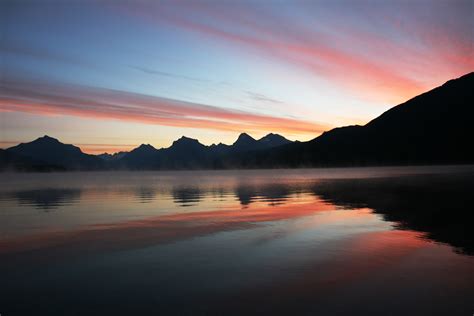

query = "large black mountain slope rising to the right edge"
[241,73,474,168]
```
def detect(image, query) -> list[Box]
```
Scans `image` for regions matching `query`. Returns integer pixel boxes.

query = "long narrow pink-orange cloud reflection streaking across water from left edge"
[0,197,334,253]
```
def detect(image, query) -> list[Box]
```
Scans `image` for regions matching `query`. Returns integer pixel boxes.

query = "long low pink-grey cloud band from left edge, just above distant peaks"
[0,80,329,135]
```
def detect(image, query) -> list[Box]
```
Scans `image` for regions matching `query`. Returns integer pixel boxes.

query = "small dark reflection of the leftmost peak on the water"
[9,189,81,211]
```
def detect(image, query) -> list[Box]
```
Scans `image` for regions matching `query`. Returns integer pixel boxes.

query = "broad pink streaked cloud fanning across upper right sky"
[123,1,474,104]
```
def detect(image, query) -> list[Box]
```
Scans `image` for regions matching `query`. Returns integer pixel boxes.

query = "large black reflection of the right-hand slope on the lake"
[313,175,474,255]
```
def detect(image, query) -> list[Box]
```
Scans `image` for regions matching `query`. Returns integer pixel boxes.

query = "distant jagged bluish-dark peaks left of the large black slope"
[0,133,292,171]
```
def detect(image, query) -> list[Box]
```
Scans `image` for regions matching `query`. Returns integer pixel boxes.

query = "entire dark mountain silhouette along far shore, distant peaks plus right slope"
[0,72,474,171]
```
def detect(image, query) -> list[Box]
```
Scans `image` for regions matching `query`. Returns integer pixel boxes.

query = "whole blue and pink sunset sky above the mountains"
[0,0,474,154]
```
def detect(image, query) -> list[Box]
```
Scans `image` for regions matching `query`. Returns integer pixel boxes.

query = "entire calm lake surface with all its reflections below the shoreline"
[0,167,474,316]
